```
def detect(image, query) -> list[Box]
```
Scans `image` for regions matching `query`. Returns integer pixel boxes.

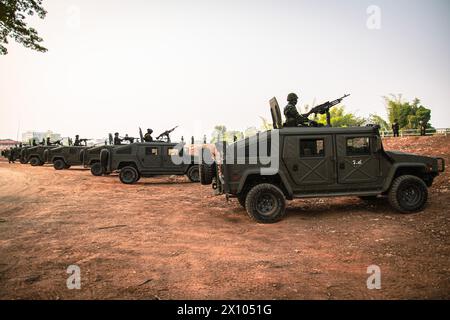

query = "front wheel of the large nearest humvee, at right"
[388,175,428,213]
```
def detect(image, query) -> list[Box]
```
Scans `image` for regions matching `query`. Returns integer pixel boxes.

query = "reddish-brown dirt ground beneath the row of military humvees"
[0,137,450,299]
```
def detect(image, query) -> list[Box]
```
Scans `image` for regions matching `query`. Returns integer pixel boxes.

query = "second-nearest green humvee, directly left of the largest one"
[100,141,199,184]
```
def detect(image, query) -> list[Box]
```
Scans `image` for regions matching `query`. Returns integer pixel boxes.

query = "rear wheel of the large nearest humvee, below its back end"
[245,183,286,223]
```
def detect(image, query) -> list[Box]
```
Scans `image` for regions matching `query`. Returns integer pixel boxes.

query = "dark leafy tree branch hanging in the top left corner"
[0,0,47,55]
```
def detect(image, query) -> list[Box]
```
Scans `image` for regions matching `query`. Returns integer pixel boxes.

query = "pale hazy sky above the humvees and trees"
[0,0,450,140]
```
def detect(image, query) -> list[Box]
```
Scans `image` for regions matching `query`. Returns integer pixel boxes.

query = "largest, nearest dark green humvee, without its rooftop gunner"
[200,99,445,223]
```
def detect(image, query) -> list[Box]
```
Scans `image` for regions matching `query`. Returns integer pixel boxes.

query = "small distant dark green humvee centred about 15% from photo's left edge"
[43,146,88,170]
